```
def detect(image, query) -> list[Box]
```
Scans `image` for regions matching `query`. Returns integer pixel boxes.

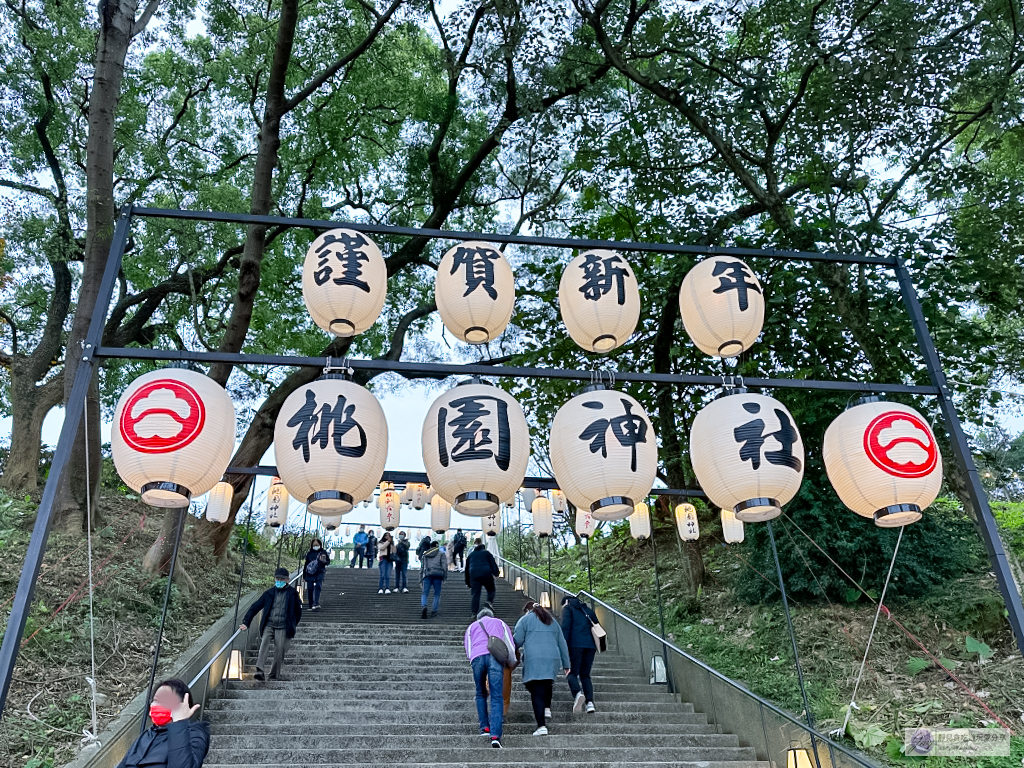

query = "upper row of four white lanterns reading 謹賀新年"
[302,229,765,357]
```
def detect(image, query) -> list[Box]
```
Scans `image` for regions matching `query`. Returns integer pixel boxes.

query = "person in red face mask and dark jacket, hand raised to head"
[118,680,210,768]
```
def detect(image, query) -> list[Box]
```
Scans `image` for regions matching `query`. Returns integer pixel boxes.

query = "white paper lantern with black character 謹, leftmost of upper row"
[302,229,387,336]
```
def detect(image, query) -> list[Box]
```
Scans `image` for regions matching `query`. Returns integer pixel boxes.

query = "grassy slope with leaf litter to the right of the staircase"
[528,509,1024,768]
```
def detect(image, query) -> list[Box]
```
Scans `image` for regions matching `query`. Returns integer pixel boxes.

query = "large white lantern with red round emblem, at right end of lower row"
[821,398,942,527]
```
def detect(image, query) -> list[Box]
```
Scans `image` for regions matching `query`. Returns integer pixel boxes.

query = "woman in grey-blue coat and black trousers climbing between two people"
[513,602,570,736]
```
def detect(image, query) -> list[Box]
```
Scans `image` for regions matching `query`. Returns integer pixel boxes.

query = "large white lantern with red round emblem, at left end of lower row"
[111,369,236,508]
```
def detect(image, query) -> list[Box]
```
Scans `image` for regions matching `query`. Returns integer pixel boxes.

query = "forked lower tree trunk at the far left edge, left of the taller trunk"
[0,376,63,494]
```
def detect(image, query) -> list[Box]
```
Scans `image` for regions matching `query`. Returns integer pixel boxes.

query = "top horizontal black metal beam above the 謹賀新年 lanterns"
[132,208,896,267]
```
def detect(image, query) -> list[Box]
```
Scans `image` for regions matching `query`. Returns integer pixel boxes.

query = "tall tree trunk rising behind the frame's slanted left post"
[58,0,138,529]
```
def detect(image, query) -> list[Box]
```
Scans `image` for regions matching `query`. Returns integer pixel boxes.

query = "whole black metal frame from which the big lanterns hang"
[0,201,1024,737]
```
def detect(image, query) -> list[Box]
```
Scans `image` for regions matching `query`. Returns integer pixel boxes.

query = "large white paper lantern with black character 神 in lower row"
[550,387,657,520]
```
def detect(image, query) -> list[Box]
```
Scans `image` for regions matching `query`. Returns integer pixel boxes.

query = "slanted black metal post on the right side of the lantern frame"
[896,258,1024,654]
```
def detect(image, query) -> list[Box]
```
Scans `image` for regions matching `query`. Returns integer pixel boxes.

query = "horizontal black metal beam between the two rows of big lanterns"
[95,347,939,396]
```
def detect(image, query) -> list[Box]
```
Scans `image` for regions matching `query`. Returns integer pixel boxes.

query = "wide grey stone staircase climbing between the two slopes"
[204,567,769,768]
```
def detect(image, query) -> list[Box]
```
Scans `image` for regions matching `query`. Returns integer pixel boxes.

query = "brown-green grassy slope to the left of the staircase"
[0,492,296,768]
